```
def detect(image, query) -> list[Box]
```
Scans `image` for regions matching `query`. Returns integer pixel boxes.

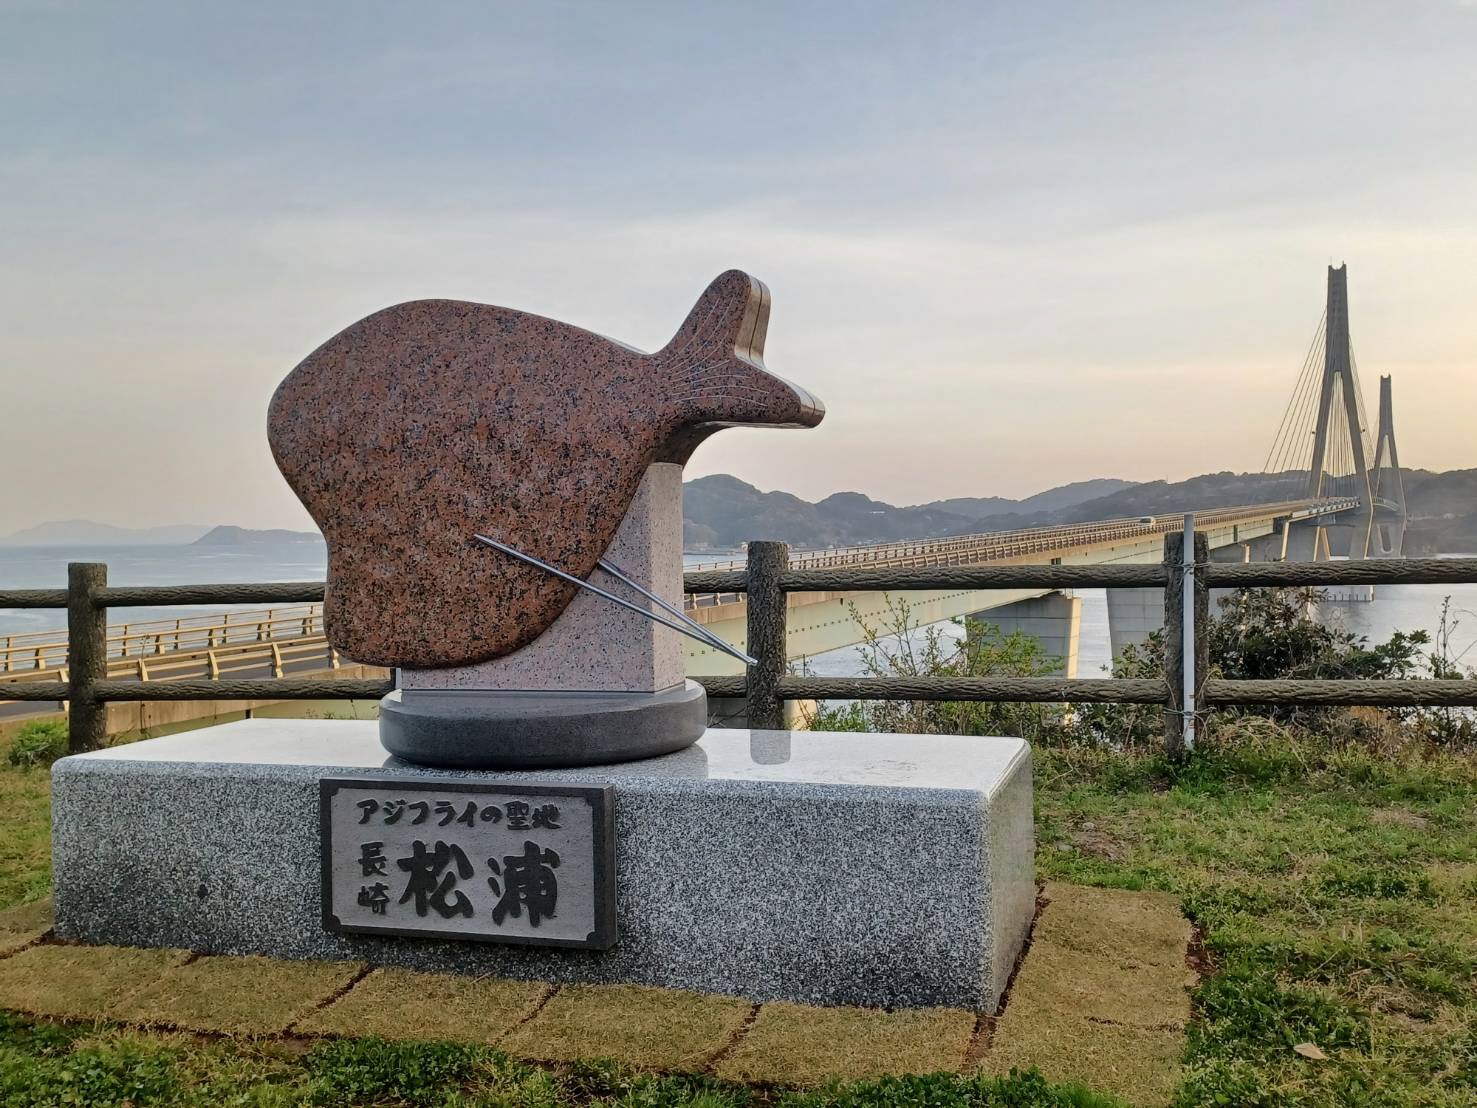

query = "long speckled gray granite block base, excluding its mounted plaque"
[52,719,1035,1010]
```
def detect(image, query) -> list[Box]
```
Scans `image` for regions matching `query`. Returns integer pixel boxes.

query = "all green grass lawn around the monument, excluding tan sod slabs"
[0,740,1477,1108]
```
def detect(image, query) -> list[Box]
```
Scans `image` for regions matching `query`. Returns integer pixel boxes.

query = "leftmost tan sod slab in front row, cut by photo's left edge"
[0,945,189,1019]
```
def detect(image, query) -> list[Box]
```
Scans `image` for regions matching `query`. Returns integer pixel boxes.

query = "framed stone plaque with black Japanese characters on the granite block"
[319,777,616,950]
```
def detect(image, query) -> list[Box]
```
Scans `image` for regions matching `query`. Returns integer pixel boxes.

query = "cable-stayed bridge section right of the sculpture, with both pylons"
[688,266,1406,677]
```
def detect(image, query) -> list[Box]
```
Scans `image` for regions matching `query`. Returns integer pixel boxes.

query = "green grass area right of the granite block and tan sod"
[1037,743,1477,1105]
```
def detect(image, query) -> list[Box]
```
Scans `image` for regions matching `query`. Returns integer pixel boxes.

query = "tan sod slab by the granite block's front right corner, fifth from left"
[718,1000,975,1086]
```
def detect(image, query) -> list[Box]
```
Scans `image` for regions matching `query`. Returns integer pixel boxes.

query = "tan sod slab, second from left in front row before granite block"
[108,956,362,1034]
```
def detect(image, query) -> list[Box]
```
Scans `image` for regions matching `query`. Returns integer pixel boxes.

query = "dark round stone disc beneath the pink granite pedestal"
[380,681,707,770]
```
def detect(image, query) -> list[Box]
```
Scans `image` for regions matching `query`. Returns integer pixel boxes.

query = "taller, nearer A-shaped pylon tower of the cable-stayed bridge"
[1307,264,1376,558]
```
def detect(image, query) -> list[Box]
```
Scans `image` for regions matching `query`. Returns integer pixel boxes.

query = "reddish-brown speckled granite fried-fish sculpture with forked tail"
[267,270,824,668]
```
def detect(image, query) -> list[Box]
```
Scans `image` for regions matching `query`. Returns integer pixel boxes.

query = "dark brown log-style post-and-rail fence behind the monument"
[0,532,1477,750]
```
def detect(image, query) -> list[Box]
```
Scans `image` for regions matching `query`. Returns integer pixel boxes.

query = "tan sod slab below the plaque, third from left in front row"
[294,969,549,1043]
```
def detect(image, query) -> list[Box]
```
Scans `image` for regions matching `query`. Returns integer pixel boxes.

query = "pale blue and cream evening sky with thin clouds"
[0,0,1477,533]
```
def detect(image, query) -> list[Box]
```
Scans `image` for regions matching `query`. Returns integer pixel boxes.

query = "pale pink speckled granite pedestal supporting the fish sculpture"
[400,462,690,693]
